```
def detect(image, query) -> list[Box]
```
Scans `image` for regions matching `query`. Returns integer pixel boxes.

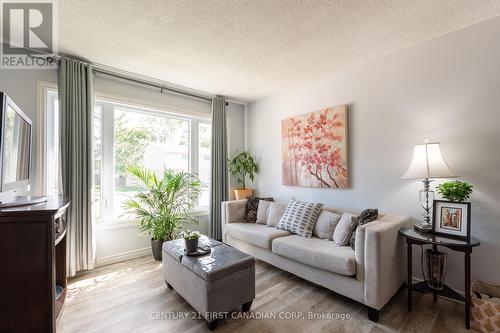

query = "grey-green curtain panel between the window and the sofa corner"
[210,97,228,240]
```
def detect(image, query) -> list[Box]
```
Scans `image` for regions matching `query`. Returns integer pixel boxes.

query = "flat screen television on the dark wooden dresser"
[0,92,32,193]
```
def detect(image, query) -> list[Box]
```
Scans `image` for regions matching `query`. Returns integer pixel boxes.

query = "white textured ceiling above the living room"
[58,0,500,101]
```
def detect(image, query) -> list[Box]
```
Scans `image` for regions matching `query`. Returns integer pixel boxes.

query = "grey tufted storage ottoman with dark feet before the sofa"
[162,236,255,329]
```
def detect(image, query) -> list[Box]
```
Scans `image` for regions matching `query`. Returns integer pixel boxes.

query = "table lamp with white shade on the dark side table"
[401,142,457,231]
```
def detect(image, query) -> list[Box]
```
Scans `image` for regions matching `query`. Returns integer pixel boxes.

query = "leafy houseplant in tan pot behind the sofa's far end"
[228,150,259,200]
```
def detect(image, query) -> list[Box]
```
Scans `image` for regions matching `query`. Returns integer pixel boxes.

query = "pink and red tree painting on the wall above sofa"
[281,105,349,188]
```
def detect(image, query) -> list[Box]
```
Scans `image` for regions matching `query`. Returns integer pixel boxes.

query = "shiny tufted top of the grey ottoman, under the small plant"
[163,236,255,281]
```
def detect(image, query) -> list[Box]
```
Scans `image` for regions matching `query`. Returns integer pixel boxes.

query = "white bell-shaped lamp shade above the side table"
[401,143,457,179]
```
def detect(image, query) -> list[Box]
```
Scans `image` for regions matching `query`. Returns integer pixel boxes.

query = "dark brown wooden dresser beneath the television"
[0,196,70,333]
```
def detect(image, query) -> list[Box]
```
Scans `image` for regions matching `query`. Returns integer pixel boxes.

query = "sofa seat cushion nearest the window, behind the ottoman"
[224,223,290,250]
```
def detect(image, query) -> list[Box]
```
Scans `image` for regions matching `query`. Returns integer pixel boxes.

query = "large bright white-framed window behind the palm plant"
[94,99,210,221]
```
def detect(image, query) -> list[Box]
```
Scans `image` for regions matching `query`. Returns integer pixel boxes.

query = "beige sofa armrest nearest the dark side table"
[362,215,411,310]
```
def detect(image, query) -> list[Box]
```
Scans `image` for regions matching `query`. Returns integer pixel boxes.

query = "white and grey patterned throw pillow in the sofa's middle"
[276,198,323,238]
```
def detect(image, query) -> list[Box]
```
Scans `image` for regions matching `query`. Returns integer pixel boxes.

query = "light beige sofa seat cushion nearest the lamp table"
[272,235,356,276]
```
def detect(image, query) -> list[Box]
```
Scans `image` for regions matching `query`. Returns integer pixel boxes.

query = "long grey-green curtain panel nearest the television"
[58,58,95,276]
